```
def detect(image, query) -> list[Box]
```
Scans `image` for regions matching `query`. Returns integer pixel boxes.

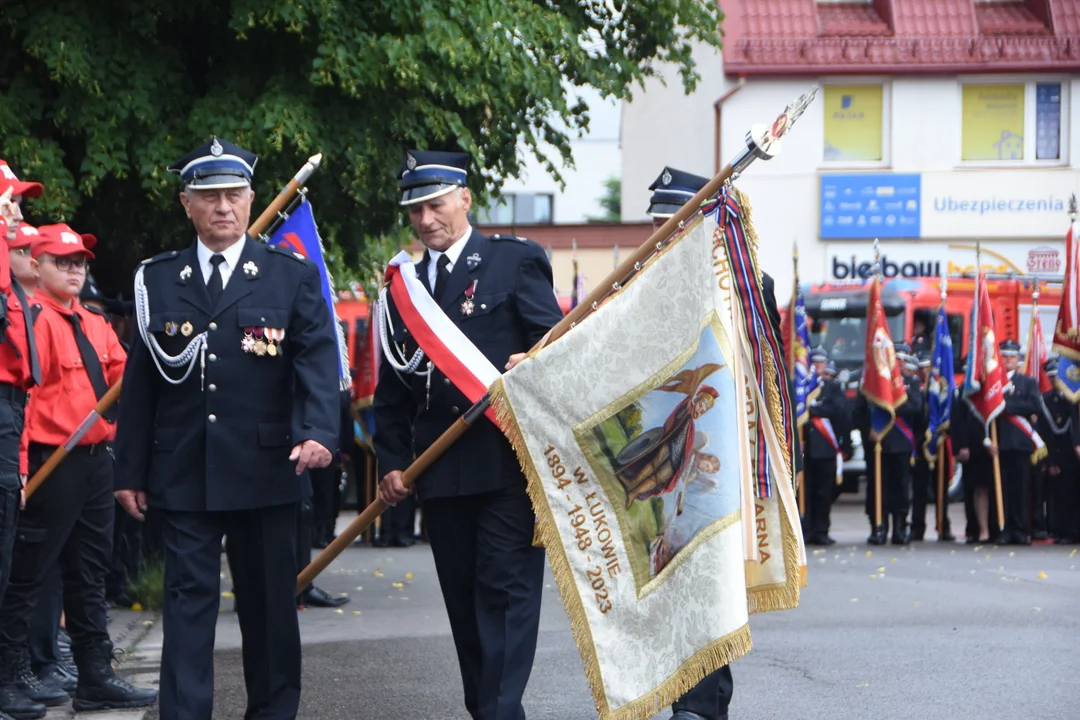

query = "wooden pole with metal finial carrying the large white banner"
[296,85,818,593]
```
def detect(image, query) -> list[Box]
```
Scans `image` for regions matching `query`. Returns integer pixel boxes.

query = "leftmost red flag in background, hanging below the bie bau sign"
[861,277,907,436]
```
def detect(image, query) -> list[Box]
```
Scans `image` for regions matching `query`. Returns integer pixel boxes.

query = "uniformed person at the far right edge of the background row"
[1038,356,1080,544]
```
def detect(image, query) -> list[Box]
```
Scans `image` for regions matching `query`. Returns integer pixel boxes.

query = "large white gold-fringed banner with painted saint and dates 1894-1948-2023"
[489,193,806,720]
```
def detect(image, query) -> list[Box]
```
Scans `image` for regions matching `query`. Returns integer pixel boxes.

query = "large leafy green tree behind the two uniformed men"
[0,0,720,289]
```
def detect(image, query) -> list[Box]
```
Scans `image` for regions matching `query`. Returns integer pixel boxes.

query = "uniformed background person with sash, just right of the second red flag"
[991,340,1042,545]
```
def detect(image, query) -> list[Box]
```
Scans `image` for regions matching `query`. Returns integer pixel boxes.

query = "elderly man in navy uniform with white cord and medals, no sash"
[117,137,339,720]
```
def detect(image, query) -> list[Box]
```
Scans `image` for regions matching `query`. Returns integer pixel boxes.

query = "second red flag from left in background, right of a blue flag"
[963,272,1009,433]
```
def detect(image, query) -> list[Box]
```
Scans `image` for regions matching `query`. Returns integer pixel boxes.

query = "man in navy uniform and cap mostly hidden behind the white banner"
[648,167,801,720]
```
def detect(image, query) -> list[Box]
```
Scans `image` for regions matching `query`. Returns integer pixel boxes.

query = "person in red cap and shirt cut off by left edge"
[0,160,45,720]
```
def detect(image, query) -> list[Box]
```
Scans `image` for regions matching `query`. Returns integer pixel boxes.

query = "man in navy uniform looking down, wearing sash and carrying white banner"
[374,151,562,720]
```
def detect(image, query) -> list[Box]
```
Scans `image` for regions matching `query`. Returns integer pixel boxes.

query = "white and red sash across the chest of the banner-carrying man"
[386,250,501,424]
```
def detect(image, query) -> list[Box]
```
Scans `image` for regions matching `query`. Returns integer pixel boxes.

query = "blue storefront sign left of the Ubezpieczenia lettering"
[820,173,921,240]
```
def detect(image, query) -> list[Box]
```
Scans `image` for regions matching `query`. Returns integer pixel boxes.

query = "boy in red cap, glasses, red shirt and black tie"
[0,225,157,710]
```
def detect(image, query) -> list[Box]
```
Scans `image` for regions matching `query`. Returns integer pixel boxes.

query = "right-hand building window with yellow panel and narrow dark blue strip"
[960,81,1066,164]
